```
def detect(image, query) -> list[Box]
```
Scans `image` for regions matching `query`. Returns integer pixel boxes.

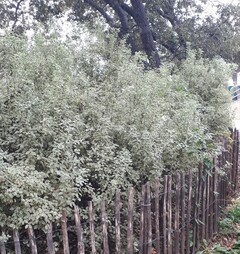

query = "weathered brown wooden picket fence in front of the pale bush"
[0,130,239,254]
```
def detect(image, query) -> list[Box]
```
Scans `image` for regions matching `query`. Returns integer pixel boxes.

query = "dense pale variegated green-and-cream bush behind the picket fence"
[0,32,231,226]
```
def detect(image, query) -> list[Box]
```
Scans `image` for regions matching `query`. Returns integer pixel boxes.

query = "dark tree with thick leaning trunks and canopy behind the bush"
[0,0,240,67]
